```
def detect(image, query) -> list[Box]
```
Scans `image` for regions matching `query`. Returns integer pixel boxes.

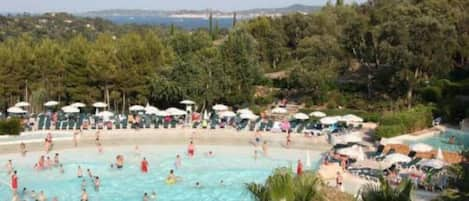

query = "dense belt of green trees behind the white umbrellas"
[0,0,469,124]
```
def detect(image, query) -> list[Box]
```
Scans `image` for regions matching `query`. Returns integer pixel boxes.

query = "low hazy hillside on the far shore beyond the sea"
[81,4,321,18]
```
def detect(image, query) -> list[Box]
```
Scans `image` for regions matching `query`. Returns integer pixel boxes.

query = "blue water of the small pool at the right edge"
[405,129,469,152]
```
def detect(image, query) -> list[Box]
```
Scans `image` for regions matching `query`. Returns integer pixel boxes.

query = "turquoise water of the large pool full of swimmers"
[0,146,320,201]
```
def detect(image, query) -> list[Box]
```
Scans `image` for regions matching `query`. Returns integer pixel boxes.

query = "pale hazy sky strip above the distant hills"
[0,0,358,12]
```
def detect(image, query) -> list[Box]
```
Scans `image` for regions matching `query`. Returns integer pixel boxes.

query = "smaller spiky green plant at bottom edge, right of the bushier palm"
[360,177,412,201]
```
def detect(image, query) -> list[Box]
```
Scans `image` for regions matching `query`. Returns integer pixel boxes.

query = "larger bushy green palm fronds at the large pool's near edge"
[246,169,324,201]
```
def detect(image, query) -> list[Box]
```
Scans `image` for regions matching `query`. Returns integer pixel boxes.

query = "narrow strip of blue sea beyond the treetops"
[104,16,233,30]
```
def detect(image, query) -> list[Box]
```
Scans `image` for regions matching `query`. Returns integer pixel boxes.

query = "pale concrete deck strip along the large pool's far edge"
[0,128,331,153]
